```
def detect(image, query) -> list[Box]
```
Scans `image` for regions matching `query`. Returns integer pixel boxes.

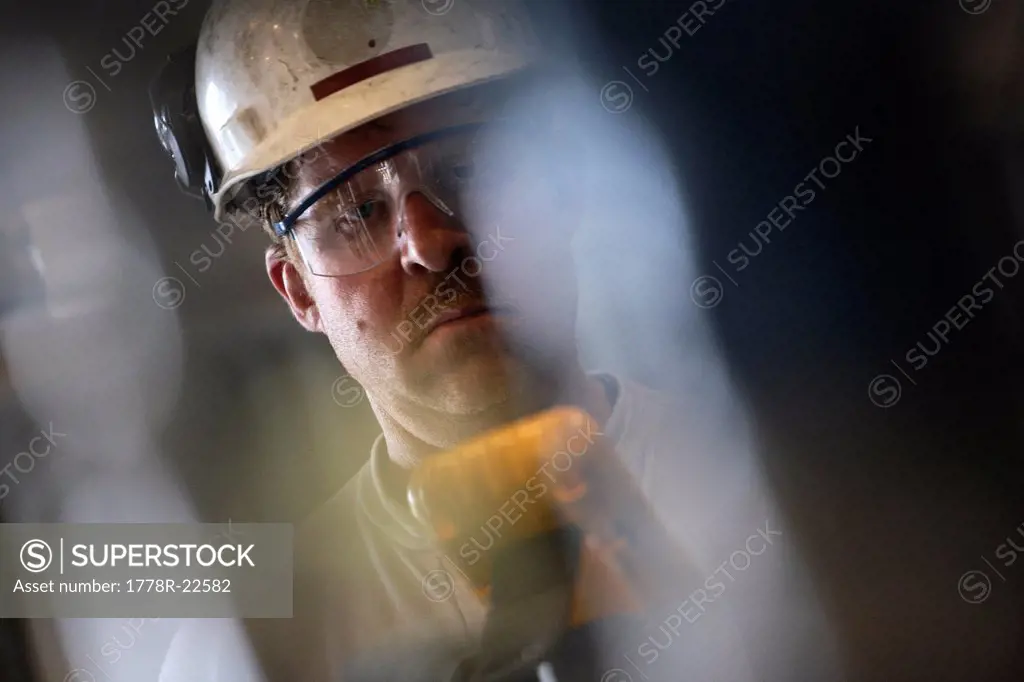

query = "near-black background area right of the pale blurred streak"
[536,0,1024,680]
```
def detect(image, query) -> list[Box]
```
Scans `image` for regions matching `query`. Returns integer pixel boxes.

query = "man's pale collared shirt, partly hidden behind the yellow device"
[155,375,831,682]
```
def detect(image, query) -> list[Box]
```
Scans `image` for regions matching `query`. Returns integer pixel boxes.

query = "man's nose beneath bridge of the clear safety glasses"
[400,191,470,274]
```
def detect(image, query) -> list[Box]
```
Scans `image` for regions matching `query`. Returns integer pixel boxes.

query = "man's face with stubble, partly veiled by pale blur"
[268,82,577,416]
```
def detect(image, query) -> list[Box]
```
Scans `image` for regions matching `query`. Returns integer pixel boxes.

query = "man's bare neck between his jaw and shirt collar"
[375,370,614,503]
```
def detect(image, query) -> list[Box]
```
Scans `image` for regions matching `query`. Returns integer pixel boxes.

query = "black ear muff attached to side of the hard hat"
[150,43,220,208]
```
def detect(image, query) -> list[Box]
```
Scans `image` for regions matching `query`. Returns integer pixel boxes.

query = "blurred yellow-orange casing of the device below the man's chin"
[409,407,681,627]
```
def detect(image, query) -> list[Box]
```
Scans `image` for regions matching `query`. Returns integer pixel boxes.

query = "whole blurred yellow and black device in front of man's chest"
[391,408,739,680]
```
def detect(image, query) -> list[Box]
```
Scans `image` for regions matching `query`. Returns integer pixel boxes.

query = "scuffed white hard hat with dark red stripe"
[196,0,539,220]
